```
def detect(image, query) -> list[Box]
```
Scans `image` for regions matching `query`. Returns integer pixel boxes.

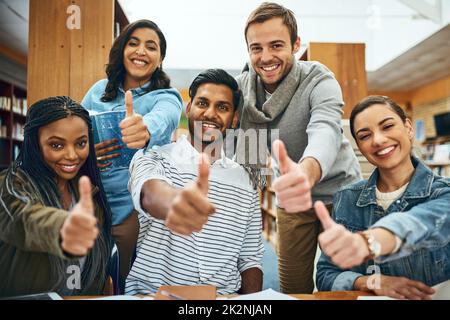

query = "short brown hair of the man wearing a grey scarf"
[244,2,298,46]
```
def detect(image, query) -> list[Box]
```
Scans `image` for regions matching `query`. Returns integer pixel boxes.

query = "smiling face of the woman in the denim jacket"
[354,104,413,170]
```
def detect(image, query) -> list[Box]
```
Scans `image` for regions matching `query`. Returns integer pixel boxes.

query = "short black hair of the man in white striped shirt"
[189,69,242,111]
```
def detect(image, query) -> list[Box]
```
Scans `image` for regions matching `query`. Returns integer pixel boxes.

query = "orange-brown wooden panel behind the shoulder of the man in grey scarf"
[307,42,367,119]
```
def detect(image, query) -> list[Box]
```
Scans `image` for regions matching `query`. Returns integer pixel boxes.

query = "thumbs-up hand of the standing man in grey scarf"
[272,140,312,212]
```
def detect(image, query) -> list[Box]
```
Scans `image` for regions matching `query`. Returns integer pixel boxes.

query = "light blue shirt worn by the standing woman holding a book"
[81,79,183,225]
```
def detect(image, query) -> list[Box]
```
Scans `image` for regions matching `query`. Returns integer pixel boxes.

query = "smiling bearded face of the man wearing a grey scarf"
[246,18,300,93]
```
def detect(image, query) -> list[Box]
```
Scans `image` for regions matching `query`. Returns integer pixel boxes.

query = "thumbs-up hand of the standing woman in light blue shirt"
[119,90,150,149]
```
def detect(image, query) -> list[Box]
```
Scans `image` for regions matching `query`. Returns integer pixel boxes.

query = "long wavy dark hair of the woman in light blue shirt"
[100,19,170,102]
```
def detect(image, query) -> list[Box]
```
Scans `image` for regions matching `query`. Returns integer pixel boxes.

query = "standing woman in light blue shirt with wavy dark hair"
[82,20,183,287]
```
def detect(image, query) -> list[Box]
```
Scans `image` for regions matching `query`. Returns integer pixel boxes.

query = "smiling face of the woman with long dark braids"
[38,116,89,184]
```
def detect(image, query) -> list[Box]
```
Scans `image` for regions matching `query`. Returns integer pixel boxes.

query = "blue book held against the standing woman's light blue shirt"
[89,110,138,170]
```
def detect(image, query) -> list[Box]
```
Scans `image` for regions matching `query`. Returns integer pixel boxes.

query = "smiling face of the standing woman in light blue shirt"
[123,28,162,90]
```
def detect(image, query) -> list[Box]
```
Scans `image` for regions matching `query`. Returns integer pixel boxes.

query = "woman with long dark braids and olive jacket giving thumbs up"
[0,97,112,296]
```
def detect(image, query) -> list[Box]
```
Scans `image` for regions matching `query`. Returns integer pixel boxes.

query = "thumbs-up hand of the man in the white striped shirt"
[166,153,216,235]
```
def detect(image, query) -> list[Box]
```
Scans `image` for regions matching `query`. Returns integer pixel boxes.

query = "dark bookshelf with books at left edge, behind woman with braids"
[0,80,27,170]
